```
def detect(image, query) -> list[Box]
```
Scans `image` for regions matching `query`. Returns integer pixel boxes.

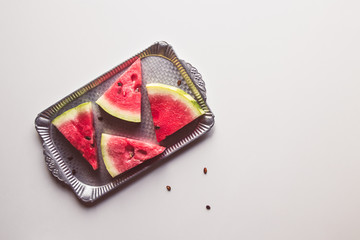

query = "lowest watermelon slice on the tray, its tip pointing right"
[101,133,165,177]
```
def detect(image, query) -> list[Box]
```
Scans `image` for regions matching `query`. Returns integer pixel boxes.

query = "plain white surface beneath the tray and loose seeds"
[0,0,360,240]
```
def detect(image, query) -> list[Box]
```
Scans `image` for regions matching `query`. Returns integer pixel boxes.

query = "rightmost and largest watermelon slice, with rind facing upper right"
[146,83,205,142]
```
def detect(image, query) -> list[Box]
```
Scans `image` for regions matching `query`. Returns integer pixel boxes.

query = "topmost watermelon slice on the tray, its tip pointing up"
[96,58,142,122]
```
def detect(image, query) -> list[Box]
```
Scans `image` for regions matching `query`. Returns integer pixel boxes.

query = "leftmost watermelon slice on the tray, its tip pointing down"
[52,102,98,170]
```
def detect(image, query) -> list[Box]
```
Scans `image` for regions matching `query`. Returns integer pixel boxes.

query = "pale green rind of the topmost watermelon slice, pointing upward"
[96,96,141,122]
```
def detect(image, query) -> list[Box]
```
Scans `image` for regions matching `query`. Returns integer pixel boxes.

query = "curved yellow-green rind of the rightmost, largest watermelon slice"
[146,83,205,117]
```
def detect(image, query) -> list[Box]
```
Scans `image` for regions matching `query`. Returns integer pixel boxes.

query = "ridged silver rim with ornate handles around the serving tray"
[35,41,215,203]
